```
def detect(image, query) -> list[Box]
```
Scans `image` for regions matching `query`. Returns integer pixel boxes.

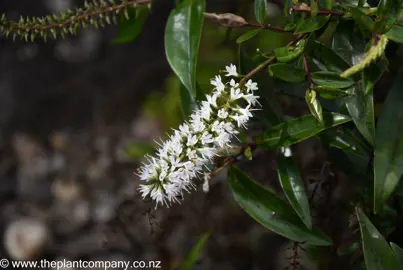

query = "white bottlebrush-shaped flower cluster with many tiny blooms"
[139,64,259,207]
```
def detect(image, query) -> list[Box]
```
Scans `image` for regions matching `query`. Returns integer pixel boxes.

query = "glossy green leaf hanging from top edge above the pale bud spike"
[375,0,402,34]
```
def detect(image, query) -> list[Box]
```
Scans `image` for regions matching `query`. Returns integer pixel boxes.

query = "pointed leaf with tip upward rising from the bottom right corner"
[357,208,402,270]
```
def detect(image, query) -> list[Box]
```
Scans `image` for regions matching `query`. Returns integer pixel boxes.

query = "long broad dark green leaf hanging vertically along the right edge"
[374,75,403,213]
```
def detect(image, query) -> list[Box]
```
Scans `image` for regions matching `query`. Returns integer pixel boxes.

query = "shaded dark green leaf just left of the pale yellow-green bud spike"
[312,41,350,72]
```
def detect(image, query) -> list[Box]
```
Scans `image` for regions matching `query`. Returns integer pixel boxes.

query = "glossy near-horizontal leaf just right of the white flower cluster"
[257,113,351,148]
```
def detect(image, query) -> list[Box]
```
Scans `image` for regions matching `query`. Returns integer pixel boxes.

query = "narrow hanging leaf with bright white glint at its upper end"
[276,146,312,229]
